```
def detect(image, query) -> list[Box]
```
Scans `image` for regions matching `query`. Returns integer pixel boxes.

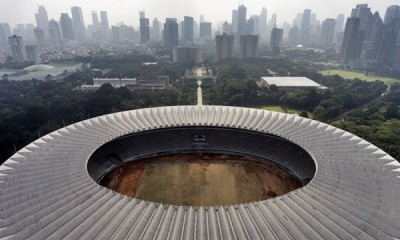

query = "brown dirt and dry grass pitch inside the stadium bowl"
[100,154,302,206]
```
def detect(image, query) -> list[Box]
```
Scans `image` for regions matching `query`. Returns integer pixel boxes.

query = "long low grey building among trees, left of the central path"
[75,76,169,91]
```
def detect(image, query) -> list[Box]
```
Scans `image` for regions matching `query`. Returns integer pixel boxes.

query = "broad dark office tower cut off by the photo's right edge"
[373,18,400,65]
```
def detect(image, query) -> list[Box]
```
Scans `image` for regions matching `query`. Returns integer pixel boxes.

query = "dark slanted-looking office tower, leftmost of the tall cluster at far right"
[340,18,363,64]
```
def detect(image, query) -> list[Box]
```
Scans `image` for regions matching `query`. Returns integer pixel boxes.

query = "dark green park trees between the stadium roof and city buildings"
[0,57,400,162]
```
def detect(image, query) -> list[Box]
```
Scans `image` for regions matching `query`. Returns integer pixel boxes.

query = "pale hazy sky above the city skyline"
[0,0,400,27]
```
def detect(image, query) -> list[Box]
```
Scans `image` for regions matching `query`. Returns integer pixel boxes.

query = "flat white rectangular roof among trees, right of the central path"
[261,77,324,88]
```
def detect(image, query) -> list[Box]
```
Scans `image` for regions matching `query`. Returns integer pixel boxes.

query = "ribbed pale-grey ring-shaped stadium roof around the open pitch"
[0,106,400,240]
